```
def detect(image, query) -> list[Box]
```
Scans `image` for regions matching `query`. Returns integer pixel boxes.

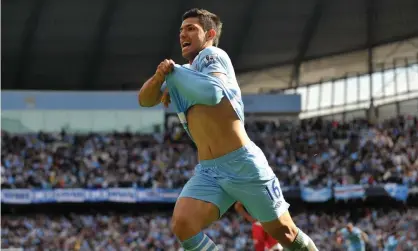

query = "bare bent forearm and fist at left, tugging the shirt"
[138,59,174,107]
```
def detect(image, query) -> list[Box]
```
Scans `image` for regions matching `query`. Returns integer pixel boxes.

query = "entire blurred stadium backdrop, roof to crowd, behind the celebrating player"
[1,0,418,251]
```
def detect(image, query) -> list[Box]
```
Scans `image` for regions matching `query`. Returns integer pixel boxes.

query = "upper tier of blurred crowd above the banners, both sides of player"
[1,117,418,188]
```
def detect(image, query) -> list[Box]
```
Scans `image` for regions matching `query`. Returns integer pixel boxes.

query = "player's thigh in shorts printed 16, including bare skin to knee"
[217,146,297,243]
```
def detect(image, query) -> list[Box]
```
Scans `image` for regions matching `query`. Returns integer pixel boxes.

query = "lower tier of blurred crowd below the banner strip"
[1,209,418,251]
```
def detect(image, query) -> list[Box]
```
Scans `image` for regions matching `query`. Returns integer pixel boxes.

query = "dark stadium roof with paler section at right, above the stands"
[2,0,418,92]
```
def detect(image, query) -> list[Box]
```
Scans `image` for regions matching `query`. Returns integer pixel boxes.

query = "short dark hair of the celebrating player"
[183,8,222,46]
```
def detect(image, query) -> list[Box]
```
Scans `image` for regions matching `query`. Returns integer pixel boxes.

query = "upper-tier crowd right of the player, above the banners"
[249,114,418,186]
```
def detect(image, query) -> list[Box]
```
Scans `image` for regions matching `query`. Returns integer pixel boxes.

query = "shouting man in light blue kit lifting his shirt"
[139,9,317,251]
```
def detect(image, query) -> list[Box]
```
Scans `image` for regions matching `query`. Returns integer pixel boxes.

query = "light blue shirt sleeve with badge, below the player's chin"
[198,47,228,75]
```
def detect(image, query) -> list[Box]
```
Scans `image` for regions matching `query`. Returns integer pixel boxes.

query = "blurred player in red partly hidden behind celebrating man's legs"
[234,202,283,251]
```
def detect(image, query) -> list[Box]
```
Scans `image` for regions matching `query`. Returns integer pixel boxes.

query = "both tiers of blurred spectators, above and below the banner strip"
[1,114,418,251]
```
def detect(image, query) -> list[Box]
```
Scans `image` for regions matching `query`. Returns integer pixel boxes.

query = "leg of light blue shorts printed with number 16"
[218,144,289,222]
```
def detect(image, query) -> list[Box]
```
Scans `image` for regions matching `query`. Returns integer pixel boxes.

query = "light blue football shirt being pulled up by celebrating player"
[162,46,244,140]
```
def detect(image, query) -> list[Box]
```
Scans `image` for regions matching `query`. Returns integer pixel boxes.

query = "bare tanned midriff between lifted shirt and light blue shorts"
[187,98,250,160]
